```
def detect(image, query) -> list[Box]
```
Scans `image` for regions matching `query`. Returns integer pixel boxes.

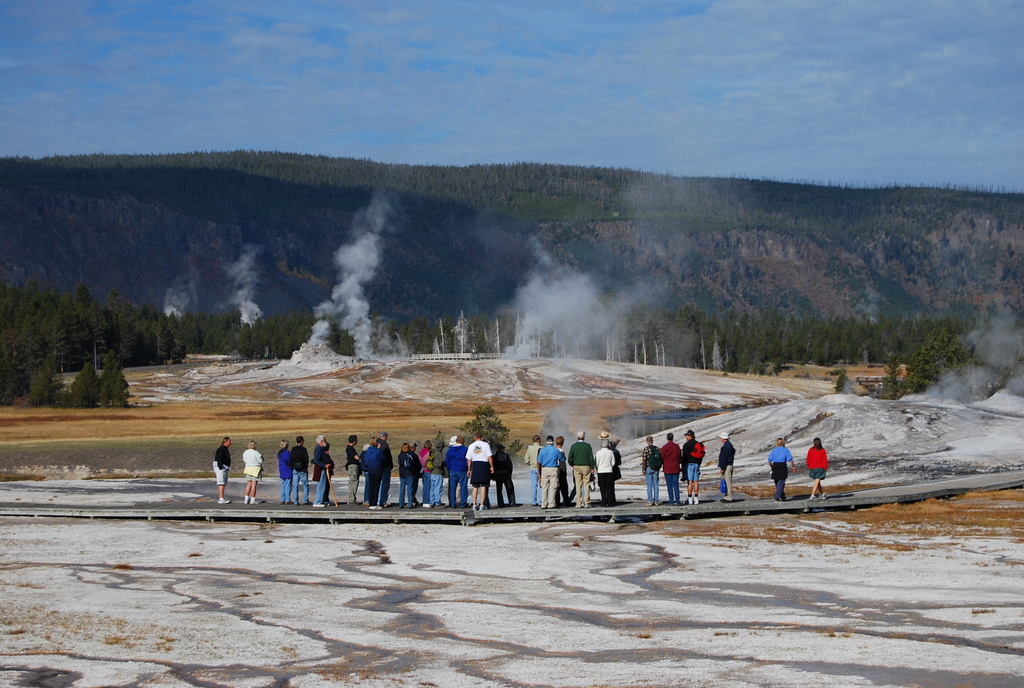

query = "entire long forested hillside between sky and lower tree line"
[0,152,1024,318]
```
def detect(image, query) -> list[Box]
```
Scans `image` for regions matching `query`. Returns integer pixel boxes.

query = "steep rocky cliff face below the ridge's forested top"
[0,176,1024,316]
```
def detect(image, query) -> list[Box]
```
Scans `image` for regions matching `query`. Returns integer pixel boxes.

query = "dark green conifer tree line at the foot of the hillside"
[0,283,991,406]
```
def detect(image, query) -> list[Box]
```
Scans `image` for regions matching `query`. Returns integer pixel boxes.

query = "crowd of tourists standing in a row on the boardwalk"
[213,430,828,511]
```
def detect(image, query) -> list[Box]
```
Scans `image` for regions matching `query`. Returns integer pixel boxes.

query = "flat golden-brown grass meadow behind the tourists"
[0,398,633,477]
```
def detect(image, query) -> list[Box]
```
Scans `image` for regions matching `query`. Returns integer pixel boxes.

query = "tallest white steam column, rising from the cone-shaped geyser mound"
[309,196,391,358]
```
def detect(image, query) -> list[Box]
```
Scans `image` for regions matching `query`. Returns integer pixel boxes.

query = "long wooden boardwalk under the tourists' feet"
[0,471,1024,525]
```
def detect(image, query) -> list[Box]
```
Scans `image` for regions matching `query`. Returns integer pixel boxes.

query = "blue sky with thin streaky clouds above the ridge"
[0,0,1024,190]
